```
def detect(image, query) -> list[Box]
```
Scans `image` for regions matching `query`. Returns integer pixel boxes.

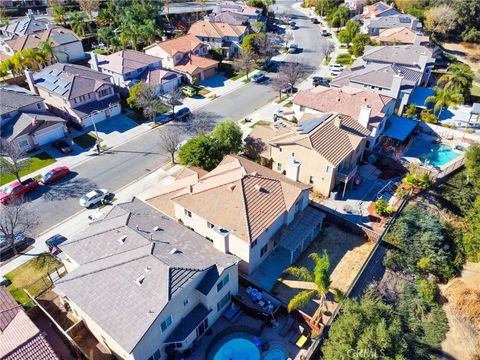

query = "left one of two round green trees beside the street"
[178,133,223,171]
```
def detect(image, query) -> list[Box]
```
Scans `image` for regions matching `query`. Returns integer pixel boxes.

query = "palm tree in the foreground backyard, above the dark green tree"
[285,251,331,325]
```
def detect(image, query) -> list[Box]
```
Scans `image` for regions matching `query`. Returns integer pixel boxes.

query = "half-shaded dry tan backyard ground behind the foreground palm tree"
[272,223,374,323]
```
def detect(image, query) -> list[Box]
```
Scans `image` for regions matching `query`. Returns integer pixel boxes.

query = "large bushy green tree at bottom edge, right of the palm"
[322,294,409,360]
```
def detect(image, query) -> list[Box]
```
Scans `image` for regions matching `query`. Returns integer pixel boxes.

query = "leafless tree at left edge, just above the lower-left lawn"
[0,198,37,254]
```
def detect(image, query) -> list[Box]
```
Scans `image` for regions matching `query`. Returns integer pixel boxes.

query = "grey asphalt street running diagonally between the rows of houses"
[1,1,324,245]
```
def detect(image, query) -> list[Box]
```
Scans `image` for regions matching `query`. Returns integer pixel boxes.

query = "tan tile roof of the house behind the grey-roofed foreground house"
[148,155,311,242]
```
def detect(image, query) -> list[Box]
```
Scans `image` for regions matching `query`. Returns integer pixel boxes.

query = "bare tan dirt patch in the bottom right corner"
[440,263,480,360]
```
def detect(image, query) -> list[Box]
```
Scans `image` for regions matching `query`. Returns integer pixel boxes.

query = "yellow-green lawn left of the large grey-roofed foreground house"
[5,253,62,307]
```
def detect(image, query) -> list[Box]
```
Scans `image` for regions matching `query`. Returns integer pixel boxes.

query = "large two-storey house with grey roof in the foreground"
[54,198,238,360]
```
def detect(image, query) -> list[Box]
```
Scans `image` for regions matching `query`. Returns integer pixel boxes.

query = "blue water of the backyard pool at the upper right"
[405,141,460,166]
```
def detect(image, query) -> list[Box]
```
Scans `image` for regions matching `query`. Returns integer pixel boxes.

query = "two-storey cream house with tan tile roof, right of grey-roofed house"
[148,155,323,275]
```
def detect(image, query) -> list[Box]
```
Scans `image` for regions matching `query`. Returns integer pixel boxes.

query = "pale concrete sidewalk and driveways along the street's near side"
[0,165,181,276]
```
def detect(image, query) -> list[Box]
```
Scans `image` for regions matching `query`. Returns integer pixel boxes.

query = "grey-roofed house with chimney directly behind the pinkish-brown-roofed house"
[330,63,422,114]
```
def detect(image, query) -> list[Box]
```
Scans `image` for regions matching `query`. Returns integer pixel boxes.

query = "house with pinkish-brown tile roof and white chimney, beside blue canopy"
[293,84,398,149]
